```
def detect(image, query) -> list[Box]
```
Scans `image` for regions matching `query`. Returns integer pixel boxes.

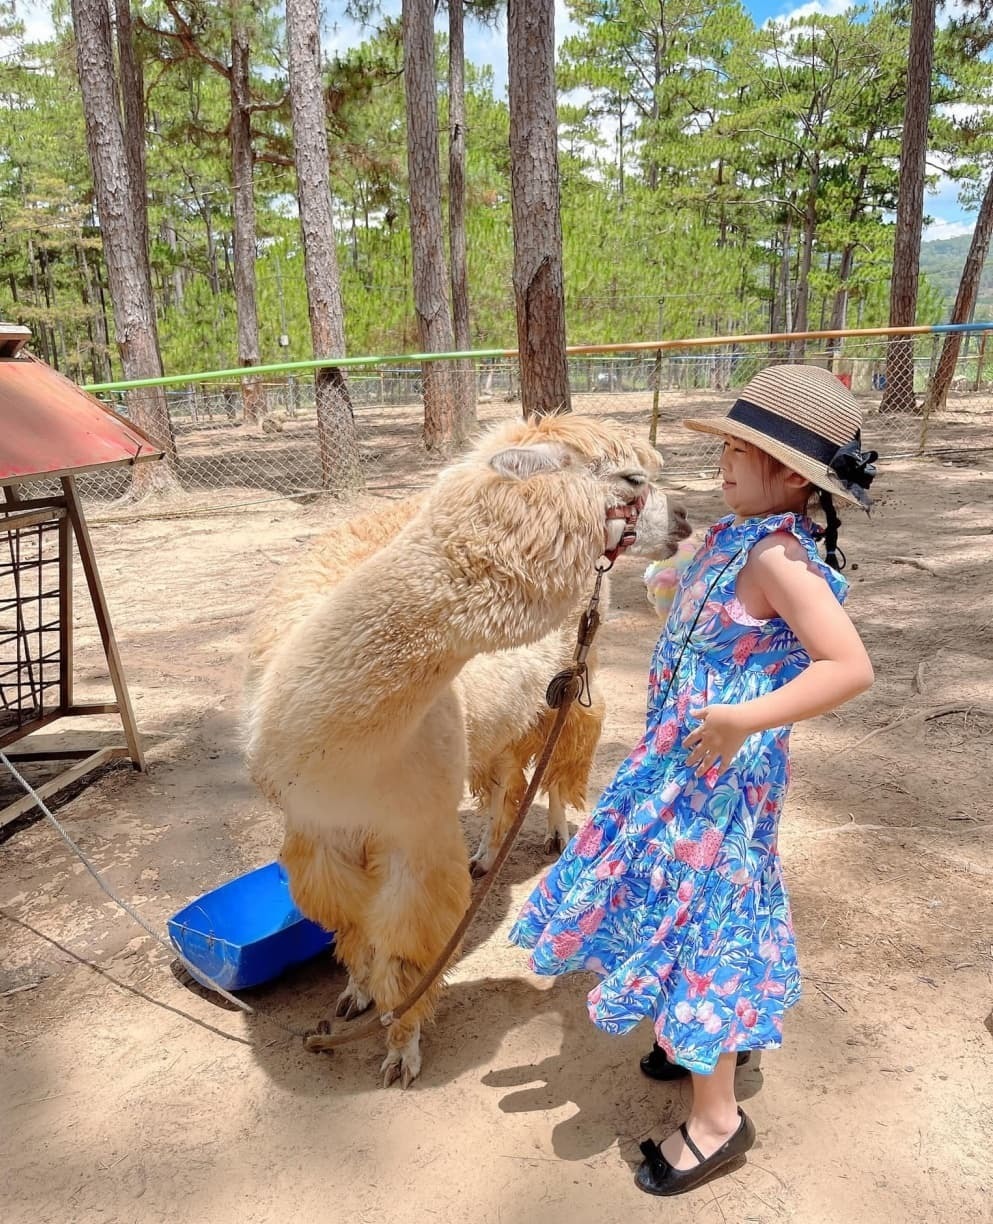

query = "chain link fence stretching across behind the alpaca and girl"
[36,330,993,520]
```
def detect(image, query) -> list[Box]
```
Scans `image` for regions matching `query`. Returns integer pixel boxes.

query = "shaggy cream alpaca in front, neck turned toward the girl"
[246,416,659,1087]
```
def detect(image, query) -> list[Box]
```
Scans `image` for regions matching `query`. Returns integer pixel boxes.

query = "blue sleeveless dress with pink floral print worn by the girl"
[511,514,846,1075]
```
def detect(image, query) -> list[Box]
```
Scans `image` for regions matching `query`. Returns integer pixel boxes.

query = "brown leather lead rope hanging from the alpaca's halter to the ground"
[304,560,616,1054]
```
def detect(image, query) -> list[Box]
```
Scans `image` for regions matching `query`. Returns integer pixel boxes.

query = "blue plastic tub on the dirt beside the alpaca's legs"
[168,863,334,990]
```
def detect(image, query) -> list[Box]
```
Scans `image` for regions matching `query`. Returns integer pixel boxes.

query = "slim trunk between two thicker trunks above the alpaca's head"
[448,0,476,433]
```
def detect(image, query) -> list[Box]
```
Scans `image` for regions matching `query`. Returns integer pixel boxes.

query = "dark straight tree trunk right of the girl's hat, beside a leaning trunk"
[879,0,935,412]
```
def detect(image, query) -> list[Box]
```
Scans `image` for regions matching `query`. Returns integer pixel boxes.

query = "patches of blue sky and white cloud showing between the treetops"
[9,0,975,241]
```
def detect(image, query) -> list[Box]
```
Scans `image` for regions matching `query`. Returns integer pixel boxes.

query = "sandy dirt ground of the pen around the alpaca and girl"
[0,398,993,1224]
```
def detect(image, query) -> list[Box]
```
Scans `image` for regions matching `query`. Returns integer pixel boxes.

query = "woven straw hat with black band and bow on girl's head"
[683,366,877,510]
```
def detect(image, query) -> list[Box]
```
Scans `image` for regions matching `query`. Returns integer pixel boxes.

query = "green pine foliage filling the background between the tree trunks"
[0,0,993,379]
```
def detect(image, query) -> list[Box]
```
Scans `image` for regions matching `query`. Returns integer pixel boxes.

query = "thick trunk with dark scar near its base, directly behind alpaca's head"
[507,0,572,416]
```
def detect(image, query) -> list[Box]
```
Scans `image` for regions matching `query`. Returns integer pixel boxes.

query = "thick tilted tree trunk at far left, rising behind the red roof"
[72,0,176,496]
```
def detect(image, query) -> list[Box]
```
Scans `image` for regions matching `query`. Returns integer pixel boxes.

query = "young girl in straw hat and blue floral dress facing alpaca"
[511,366,875,1195]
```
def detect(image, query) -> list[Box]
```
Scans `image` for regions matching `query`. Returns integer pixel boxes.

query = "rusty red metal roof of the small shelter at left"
[0,354,163,485]
